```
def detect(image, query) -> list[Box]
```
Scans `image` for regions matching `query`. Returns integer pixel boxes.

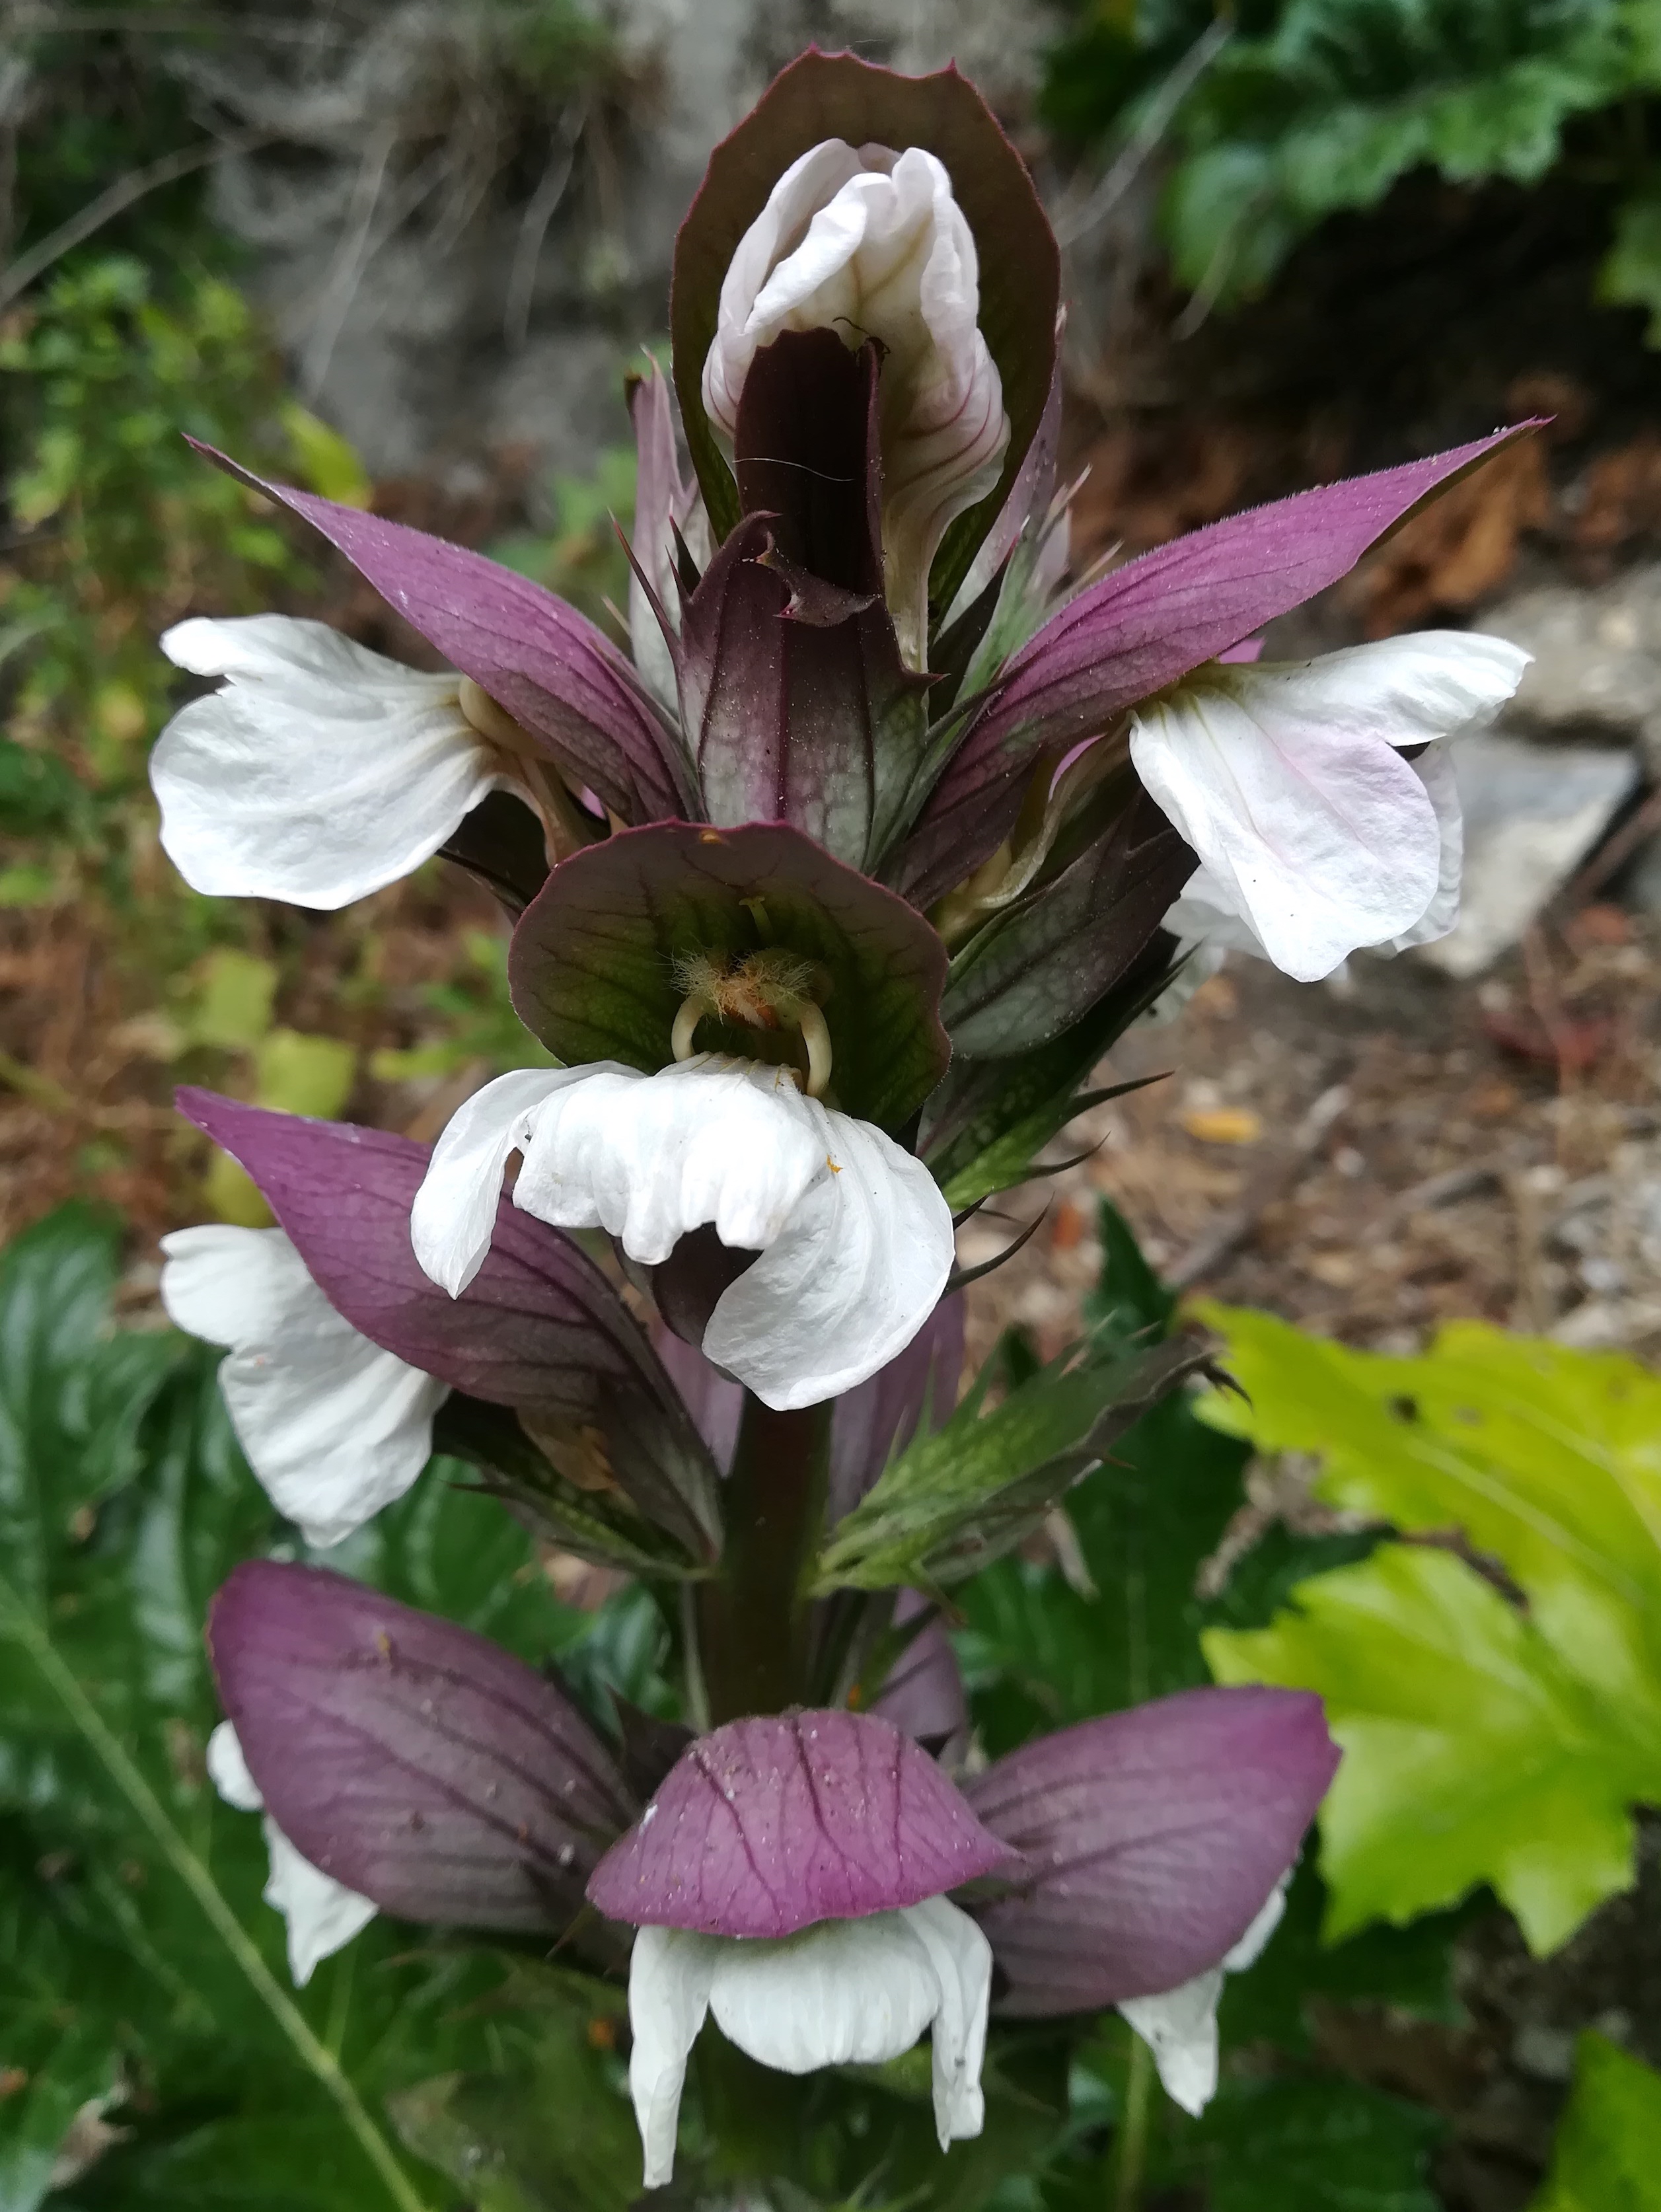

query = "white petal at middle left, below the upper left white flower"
[161,1226,449,1546]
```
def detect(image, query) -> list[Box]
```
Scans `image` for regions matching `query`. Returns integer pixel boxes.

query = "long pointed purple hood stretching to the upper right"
[911,422,1537,907]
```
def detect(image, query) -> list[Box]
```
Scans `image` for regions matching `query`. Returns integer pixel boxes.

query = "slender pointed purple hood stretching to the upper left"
[192,440,692,823]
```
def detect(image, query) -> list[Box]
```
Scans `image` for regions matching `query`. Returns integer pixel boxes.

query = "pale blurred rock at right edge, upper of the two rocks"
[1480,562,1661,772]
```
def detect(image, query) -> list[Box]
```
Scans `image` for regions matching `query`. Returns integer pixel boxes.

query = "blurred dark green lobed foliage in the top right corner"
[1044,0,1661,322]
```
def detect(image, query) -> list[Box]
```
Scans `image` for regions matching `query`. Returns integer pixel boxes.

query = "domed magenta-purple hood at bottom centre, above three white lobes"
[588,1712,1011,1936]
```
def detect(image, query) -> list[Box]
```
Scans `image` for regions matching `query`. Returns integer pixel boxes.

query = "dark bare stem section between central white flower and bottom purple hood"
[699,1396,832,1725]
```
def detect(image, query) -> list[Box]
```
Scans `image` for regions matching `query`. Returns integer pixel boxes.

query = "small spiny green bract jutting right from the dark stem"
[812,1331,1208,1593]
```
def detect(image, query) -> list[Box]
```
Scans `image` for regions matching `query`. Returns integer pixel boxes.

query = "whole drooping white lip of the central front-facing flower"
[409,1053,953,1409]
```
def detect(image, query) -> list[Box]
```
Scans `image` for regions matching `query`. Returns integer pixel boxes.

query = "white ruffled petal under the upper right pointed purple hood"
[1130,630,1528,982]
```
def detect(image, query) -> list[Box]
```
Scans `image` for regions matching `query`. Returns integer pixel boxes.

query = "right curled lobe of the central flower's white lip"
[704,1099,953,1411]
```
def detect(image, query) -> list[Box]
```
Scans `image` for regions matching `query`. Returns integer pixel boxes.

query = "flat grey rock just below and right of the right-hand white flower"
[1420,730,1639,980]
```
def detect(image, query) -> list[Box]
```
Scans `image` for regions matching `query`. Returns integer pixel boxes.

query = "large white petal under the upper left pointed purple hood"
[151,615,513,909]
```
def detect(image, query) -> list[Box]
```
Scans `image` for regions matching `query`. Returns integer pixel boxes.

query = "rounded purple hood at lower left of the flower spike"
[208,1559,632,1931]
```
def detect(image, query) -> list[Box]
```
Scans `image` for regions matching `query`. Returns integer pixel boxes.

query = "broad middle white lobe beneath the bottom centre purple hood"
[710,1913,940,2075]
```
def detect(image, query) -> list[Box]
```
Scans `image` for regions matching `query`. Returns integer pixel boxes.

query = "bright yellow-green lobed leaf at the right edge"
[1201,1308,1661,1951]
